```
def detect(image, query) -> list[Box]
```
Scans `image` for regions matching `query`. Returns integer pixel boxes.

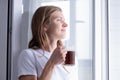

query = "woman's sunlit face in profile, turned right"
[47,11,67,40]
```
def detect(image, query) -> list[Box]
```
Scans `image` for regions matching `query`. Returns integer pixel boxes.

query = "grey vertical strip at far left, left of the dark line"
[0,0,8,80]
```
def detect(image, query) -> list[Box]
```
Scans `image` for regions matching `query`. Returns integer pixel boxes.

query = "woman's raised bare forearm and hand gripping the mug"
[38,47,67,80]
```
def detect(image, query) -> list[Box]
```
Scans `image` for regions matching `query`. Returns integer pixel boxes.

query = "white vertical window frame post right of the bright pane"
[95,0,109,80]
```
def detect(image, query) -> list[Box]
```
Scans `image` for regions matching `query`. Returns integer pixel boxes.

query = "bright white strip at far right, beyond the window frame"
[109,0,120,80]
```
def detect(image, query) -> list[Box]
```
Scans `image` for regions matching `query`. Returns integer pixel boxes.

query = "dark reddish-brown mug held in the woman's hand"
[65,51,75,65]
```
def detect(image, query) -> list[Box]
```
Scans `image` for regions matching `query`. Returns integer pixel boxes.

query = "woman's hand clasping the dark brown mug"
[50,45,67,65]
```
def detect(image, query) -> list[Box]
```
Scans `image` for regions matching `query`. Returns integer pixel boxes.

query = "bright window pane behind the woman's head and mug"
[28,0,93,80]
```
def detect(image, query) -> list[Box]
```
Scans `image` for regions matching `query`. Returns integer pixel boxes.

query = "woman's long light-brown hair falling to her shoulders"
[28,6,62,50]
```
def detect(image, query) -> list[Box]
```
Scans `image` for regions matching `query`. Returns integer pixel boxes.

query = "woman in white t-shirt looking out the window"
[18,6,77,80]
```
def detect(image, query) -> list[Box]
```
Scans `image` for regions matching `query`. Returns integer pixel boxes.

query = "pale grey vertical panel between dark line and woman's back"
[11,0,28,80]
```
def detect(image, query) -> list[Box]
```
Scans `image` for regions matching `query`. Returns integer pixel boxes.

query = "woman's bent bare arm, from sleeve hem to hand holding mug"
[19,45,67,80]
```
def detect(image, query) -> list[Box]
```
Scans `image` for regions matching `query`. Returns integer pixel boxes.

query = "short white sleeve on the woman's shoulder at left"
[18,49,37,77]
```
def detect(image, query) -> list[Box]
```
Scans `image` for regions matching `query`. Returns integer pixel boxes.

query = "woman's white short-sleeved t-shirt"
[18,49,78,80]
